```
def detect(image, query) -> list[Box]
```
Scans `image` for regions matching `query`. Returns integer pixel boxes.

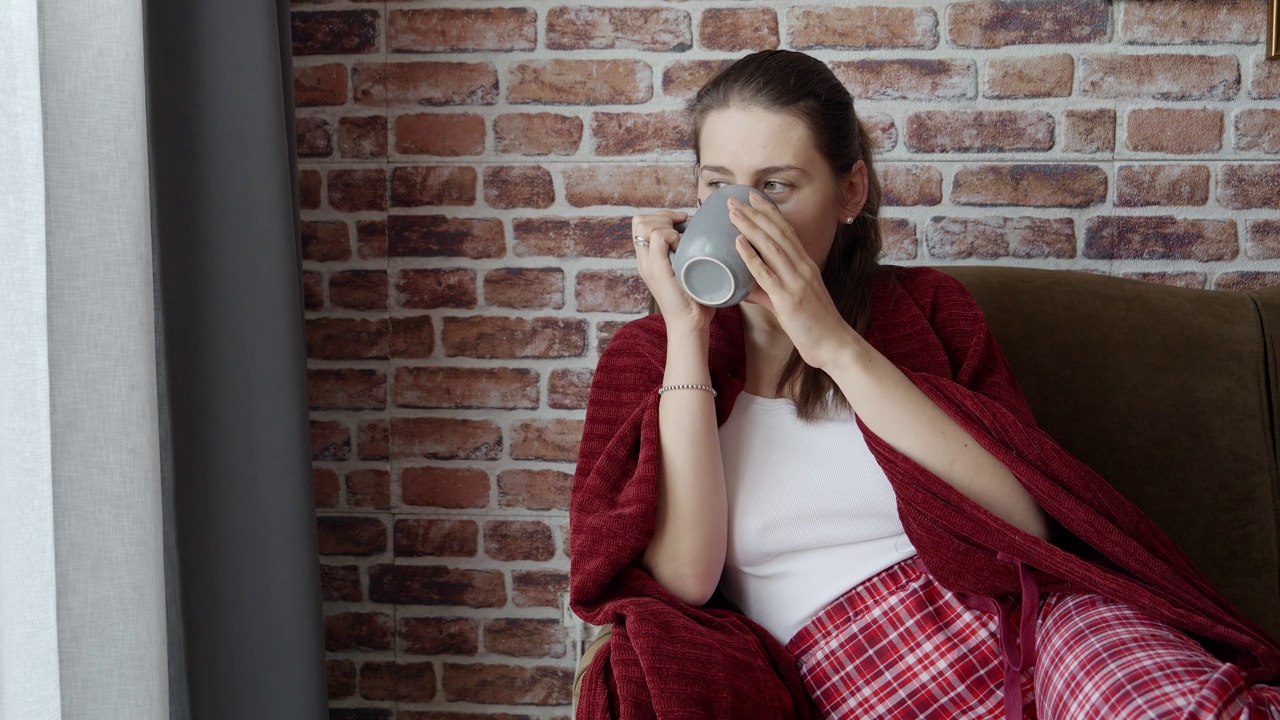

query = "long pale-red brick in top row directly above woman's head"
[787,6,938,50]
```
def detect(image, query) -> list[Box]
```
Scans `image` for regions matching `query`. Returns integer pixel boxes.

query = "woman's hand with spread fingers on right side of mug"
[728,193,856,369]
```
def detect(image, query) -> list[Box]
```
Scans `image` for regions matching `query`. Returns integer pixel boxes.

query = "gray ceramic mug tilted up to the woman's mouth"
[671,184,773,307]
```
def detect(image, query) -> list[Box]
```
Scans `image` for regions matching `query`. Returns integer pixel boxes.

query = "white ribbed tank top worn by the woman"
[719,392,915,643]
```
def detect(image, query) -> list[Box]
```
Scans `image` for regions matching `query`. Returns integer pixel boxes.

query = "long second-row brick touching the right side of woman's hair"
[831,59,978,100]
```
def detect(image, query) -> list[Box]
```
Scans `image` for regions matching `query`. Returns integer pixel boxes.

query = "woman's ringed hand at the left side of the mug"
[631,210,716,332]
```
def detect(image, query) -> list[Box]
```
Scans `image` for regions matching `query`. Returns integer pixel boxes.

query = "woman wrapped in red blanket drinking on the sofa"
[571,51,1280,717]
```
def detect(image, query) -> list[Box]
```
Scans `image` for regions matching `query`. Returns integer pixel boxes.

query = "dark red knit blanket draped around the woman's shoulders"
[570,268,1280,720]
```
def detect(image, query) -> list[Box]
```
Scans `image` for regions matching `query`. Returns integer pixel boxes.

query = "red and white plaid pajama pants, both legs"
[787,560,1280,720]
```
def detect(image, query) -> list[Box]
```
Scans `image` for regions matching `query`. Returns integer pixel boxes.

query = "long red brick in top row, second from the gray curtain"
[387,8,538,53]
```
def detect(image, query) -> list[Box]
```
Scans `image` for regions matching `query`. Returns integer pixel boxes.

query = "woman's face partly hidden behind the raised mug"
[698,108,865,268]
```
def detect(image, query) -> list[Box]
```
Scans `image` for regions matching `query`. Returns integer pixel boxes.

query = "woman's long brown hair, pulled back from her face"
[689,50,882,420]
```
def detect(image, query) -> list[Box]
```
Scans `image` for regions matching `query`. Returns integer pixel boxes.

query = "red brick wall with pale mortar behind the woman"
[293,0,1280,720]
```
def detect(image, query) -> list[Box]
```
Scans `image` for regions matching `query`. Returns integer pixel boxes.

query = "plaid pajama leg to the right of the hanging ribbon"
[1036,594,1280,720]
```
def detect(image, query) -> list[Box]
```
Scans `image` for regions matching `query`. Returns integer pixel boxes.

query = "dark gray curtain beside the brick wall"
[146,0,326,707]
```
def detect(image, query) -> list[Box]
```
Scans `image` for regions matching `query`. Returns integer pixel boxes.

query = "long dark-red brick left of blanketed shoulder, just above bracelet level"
[442,315,586,359]
